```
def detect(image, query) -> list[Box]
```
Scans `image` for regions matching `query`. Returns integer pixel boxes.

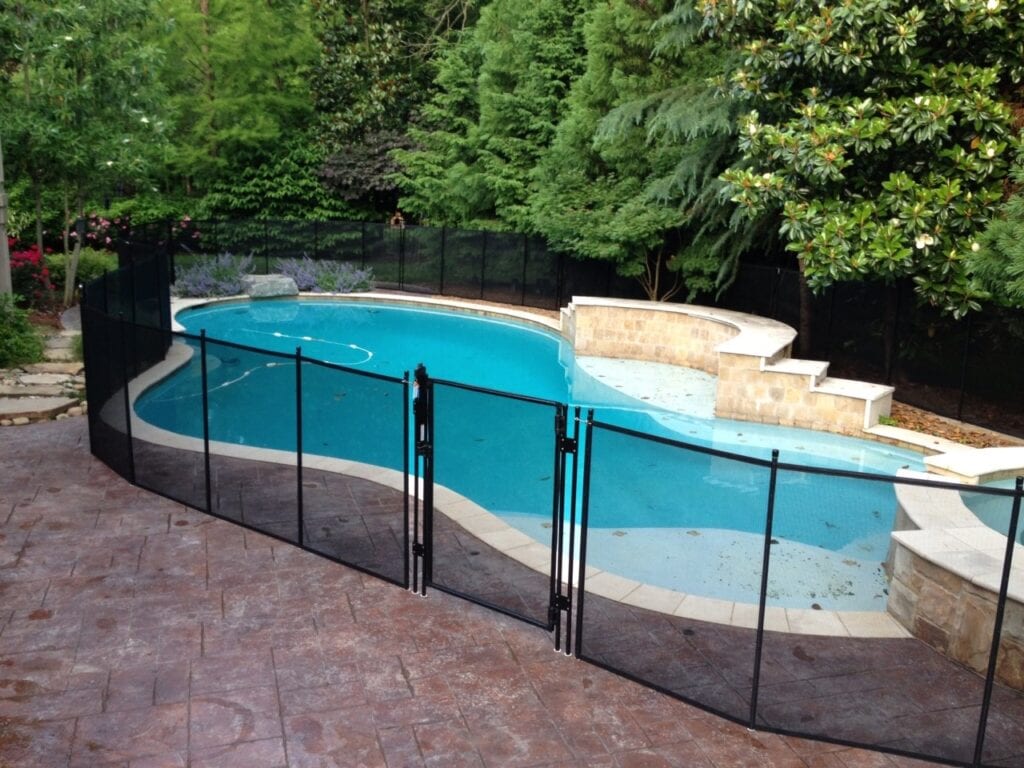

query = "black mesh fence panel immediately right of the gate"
[578,425,768,720]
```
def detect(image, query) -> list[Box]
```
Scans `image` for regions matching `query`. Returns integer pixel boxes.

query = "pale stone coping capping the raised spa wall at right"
[892,469,1024,602]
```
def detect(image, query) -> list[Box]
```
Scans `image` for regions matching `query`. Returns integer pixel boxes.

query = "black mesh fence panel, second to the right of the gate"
[758,469,991,762]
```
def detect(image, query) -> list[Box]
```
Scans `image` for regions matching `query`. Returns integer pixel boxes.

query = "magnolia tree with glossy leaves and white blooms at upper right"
[696,0,1024,316]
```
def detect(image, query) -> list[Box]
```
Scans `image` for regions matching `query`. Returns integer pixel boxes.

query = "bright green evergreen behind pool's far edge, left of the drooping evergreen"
[394,0,594,231]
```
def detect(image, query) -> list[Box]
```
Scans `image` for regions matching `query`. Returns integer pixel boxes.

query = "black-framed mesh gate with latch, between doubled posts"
[432,382,555,626]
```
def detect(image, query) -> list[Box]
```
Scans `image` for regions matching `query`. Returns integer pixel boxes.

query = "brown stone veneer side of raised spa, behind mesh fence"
[889,542,1024,690]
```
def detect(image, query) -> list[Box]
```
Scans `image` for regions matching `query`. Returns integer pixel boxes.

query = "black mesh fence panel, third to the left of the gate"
[132,327,207,510]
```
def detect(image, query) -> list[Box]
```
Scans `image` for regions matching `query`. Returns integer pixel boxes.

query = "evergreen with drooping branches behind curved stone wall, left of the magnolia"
[531,0,754,299]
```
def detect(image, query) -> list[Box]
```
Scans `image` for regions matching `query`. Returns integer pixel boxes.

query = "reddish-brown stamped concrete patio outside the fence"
[0,418,942,768]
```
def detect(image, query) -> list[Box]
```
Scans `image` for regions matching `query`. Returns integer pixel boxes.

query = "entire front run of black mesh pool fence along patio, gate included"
[82,255,1024,766]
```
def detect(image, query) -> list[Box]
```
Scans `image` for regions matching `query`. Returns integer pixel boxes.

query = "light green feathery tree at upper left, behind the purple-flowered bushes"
[154,0,316,194]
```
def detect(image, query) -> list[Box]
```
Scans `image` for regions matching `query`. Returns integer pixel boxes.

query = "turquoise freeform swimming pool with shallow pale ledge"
[135,300,922,610]
